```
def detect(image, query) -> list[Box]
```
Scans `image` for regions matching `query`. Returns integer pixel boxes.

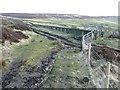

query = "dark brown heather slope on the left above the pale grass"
[0,18,30,44]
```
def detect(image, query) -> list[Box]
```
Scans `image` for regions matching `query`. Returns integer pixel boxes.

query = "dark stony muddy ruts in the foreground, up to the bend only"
[2,47,64,88]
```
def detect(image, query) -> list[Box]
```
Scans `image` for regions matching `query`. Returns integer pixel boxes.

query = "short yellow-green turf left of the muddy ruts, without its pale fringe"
[14,32,58,65]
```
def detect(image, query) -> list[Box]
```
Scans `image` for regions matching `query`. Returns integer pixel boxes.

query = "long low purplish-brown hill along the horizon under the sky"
[2,13,117,19]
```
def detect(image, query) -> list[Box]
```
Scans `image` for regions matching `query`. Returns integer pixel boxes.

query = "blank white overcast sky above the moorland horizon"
[0,0,119,16]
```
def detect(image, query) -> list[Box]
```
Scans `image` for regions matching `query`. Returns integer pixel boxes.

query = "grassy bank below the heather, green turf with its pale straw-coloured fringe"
[3,31,58,71]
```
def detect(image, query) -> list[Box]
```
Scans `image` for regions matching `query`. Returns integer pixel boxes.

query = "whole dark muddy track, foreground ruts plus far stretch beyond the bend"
[0,22,80,88]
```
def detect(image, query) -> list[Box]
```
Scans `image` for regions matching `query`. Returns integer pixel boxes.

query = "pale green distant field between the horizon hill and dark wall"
[27,18,118,28]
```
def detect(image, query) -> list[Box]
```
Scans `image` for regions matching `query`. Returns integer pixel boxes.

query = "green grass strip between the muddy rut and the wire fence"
[43,49,89,88]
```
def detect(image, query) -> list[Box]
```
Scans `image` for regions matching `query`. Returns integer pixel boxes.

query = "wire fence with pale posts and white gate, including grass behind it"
[82,32,119,88]
